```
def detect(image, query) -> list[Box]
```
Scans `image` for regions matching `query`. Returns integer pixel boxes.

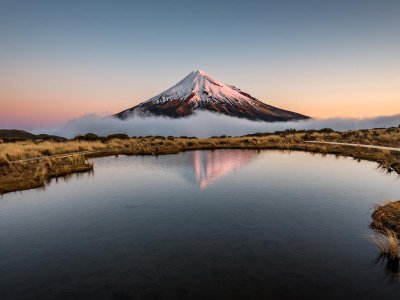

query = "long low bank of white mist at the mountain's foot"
[35,112,400,138]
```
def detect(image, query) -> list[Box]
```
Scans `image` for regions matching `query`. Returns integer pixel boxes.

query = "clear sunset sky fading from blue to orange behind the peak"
[0,0,400,129]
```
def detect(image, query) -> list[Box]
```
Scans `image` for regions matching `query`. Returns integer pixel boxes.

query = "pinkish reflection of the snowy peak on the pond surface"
[192,150,257,189]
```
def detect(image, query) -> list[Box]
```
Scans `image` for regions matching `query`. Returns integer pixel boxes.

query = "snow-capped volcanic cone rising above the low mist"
[115,71,309,122]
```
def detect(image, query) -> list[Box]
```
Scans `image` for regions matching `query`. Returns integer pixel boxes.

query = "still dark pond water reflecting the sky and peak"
[0,150,400,300]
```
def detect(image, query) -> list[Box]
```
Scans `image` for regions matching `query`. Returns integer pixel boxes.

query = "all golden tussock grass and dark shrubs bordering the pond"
[0,128,400,261]
